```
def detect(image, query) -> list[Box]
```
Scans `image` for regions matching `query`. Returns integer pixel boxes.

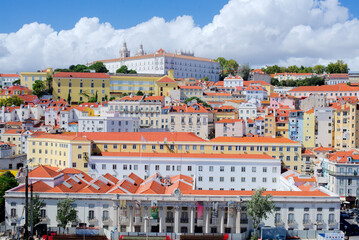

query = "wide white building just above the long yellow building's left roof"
[78,113,140,132]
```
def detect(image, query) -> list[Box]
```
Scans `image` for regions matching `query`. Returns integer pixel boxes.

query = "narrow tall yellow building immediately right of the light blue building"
[303,108,315,148]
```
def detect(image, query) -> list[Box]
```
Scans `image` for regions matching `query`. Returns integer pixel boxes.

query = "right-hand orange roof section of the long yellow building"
[210,137,298,144]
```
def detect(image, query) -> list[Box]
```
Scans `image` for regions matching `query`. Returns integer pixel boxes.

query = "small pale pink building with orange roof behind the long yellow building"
[215,119,246,137]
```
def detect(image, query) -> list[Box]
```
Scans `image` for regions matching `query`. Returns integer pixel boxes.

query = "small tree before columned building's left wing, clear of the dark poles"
[57,198,77,229]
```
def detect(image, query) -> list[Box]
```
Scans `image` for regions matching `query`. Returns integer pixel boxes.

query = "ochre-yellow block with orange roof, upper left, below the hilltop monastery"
[52,72,110,103]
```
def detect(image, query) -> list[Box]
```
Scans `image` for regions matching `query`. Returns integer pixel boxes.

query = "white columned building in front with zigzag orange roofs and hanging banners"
[5,166,340,235]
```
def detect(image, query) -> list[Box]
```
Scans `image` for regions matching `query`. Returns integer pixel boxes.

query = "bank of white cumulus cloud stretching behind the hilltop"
[0,0,359,72]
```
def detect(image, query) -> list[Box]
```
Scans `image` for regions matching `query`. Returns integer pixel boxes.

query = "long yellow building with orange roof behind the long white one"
[28,132,302,172]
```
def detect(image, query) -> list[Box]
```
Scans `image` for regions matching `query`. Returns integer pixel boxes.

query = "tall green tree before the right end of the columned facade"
[247,188,275,239]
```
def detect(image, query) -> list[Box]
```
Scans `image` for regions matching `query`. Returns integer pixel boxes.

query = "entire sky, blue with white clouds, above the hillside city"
[0,0,359,73]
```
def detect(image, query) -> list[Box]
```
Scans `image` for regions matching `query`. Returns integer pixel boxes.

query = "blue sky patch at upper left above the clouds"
[0,0,228,33]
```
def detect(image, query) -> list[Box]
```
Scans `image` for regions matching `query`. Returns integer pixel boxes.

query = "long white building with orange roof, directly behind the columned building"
[89,153,282,190]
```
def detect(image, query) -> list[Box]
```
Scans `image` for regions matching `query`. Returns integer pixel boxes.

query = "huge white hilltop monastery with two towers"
[95,43,219,81]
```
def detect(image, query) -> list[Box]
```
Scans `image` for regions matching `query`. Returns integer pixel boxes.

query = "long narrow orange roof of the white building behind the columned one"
[101,152,273,159]
